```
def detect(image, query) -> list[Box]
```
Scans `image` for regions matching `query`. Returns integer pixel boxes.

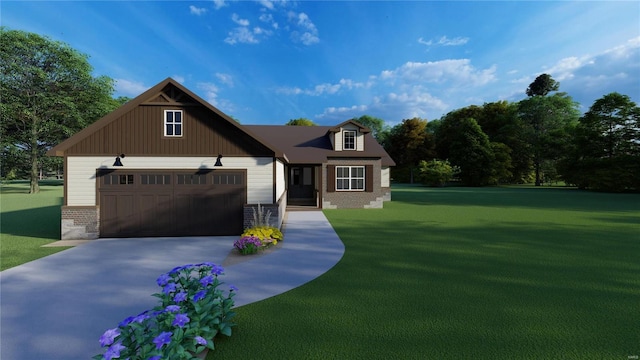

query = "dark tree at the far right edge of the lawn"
[562,92,640,192]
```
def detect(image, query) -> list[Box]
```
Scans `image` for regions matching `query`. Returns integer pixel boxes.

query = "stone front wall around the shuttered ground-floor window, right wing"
[322,159,391,209]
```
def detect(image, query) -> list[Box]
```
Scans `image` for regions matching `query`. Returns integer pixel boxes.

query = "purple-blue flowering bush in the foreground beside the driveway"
[93,263,237,360]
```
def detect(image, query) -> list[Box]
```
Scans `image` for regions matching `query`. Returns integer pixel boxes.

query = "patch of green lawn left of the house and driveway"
[0,181,68,270]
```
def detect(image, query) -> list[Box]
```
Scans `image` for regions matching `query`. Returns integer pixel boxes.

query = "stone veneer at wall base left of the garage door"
[60,206,100,240]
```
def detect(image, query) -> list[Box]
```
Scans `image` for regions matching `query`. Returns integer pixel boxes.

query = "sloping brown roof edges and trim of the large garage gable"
[47,78,284,158]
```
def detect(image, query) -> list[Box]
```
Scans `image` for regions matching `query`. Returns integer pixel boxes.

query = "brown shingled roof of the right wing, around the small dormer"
[244,125,395,166]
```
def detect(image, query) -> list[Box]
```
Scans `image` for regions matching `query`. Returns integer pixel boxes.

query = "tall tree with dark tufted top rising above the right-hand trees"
[518,74,579,186]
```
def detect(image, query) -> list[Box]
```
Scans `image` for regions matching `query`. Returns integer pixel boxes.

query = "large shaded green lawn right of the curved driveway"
[208,186,640,360]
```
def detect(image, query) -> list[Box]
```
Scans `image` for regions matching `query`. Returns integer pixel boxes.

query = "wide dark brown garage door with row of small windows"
[98,169,246,237]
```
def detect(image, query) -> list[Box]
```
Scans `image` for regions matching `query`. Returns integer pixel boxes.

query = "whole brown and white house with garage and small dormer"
[49,78,395,239]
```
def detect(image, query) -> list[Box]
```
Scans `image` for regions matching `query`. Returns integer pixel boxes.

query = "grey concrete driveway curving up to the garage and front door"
[0,211,344,360]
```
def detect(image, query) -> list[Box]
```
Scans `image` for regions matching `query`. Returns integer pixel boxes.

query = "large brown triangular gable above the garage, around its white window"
[49,78,282,157]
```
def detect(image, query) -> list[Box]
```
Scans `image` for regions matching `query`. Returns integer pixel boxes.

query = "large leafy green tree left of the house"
[0,27,117,193]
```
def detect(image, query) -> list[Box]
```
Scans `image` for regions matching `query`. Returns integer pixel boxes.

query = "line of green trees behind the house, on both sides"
[5,27,640,193]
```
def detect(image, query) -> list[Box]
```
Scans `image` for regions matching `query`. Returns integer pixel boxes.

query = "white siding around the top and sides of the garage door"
[66,156,276,206]
